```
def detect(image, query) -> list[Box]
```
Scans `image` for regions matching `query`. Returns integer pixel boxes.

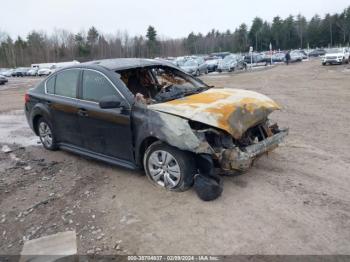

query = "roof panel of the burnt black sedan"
[81,58,176,71]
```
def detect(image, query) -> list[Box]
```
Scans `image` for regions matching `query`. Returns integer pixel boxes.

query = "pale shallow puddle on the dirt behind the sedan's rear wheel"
[0,110,40,147]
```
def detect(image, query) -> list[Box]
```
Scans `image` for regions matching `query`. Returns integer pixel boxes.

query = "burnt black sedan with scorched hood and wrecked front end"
[25,59,288,191]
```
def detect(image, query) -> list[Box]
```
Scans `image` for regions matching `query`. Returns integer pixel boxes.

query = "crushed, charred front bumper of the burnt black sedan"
[218,129,288,172]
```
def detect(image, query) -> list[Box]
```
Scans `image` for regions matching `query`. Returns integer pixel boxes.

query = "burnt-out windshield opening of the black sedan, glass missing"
[117,66,210,104]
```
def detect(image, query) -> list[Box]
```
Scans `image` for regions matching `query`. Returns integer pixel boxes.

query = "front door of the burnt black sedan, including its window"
[78,69,133,161]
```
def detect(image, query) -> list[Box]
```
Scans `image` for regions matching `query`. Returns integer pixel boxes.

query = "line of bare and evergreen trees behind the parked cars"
[0,6,350,67]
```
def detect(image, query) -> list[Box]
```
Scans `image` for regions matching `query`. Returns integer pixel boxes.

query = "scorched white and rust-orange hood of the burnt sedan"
[149,88,280,139]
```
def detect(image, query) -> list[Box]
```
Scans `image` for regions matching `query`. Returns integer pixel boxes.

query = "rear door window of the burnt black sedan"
[55,69,80,98]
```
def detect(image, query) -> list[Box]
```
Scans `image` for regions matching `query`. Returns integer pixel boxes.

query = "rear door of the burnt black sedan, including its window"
[45,69,82,146]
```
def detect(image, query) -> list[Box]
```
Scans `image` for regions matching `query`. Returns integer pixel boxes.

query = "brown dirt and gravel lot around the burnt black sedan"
[0,61,350,254]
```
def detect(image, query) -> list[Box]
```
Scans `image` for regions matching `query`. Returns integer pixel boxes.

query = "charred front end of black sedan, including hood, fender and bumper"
[149,88,288,173]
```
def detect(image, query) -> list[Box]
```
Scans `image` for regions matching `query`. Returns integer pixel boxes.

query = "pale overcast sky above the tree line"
[0,0,350,37]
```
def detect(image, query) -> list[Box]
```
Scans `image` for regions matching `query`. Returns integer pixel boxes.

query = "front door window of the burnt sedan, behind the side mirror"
[82,70,118,102]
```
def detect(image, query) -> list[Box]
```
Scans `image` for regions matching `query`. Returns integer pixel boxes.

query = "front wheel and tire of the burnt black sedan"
[143,141,196,192]
